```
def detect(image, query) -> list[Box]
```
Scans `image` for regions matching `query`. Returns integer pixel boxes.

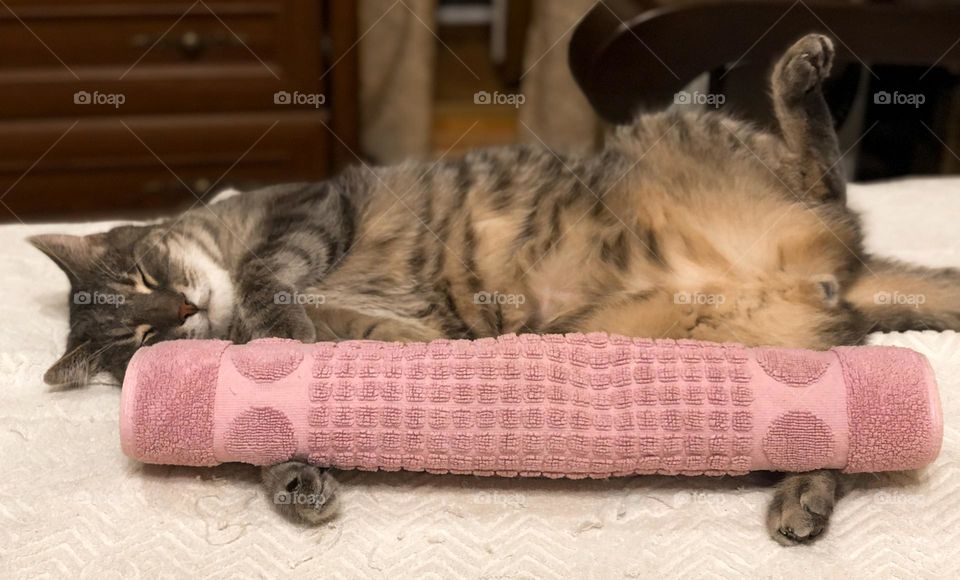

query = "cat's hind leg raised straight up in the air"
[765,34,846,202]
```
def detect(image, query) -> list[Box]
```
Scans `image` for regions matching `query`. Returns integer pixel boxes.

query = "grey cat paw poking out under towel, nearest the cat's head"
[262,461,339,524]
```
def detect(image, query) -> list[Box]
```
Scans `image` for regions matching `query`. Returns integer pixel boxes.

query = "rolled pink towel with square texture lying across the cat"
[120,333,943,478]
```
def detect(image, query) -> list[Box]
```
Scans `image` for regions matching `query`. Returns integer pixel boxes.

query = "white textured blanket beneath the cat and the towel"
[0,179,960,579]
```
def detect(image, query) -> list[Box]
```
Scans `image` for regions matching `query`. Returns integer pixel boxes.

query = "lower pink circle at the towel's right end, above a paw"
[763,411,835,471]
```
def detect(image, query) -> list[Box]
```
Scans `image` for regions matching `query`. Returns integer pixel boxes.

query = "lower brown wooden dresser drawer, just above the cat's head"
[0,112,329,222]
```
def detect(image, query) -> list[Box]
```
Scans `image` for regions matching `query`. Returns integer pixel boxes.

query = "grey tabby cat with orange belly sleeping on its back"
[31,34,960,545]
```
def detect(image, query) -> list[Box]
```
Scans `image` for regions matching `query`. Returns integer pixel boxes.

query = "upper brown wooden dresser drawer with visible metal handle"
[0,0,322,118]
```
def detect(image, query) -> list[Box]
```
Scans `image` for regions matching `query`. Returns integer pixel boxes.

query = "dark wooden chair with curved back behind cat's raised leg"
[569,0,960,178]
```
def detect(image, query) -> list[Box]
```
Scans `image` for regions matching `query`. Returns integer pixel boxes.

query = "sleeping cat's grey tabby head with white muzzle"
[29,226,233,386]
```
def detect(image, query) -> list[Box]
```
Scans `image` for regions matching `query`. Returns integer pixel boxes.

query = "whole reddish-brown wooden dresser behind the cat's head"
[0,0,357,222]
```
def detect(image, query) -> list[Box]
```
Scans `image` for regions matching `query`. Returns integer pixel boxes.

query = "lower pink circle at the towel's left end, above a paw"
[225,407,297,465]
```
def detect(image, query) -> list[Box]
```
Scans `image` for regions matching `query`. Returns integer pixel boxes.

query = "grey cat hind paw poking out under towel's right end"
[767,469,848,546]
